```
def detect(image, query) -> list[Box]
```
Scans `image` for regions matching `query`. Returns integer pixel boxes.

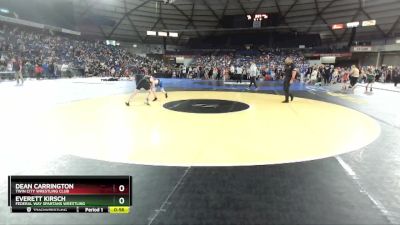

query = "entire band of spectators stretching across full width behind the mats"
[0,23,400,88]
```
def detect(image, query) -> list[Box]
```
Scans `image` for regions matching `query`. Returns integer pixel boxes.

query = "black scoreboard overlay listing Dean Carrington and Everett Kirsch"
[8,176,132,214]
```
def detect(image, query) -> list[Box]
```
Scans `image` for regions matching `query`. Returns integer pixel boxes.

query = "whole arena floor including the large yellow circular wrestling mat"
[0,78,400,224]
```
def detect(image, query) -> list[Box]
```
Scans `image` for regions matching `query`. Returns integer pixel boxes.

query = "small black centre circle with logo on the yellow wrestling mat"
[163,99,250,113]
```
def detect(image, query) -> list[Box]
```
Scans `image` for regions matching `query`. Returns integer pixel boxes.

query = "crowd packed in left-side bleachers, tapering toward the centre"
[0,24,163,78]
